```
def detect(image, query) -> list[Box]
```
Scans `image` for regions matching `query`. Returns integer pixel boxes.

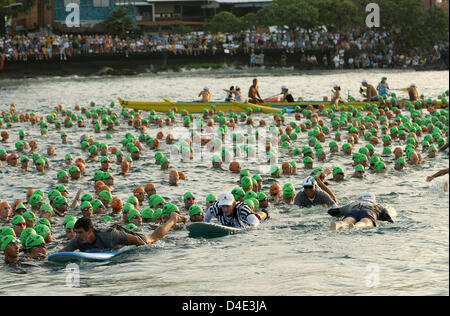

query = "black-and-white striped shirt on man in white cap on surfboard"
[205,202,259,228]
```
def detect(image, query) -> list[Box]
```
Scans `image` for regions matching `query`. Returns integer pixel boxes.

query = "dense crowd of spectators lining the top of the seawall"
[0,30,448,69]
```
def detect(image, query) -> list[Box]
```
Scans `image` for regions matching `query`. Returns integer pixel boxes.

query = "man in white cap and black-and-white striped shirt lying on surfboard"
[205,193,269,229]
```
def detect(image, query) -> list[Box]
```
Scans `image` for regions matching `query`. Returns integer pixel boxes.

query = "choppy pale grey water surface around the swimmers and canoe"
[0,70,449,295]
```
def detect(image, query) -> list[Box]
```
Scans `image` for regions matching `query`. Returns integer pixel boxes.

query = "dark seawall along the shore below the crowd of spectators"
[0,49,449,80]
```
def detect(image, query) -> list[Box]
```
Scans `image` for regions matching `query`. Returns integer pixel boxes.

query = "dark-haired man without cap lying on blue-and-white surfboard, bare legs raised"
[59,212,187,252]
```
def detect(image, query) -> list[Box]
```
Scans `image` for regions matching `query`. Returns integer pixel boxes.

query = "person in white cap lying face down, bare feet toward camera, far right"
[328,193,394,230]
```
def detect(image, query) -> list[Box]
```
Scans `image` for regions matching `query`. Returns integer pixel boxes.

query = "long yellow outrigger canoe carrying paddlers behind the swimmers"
[119,98,448,113]
